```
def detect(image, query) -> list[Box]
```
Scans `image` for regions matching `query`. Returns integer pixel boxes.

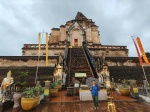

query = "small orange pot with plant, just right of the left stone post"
[50,82,58,97]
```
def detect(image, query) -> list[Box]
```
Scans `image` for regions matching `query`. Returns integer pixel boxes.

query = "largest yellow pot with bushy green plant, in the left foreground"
[21,85,43,110]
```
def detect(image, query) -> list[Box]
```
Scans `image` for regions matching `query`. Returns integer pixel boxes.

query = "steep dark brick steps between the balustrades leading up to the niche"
[69,47,93,82]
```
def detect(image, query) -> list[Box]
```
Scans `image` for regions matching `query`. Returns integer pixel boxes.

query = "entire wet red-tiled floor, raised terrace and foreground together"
[4,90,150,112]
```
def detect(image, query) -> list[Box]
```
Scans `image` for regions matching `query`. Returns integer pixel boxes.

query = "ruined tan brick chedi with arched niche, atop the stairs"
[22,12,128,57]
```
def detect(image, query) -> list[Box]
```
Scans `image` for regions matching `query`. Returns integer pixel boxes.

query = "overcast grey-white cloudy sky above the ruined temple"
[0,0,150,57]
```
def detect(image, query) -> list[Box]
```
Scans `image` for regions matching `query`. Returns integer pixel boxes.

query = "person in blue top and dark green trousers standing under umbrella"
[90,80,100,109]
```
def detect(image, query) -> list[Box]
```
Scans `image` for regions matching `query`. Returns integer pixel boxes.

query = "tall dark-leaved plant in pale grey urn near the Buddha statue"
[13,72,28,108]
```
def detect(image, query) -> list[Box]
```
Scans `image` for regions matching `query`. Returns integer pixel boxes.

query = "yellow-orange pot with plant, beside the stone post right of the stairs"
[119,80,130,96]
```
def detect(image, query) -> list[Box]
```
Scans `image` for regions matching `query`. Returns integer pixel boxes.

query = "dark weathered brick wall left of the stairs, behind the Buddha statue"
[0,66,54,83]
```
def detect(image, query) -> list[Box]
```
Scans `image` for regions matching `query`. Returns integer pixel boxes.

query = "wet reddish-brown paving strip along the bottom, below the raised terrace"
[4,101,150,112]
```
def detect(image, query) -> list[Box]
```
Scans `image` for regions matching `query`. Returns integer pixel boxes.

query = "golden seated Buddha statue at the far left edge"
[1,70,14,89]
